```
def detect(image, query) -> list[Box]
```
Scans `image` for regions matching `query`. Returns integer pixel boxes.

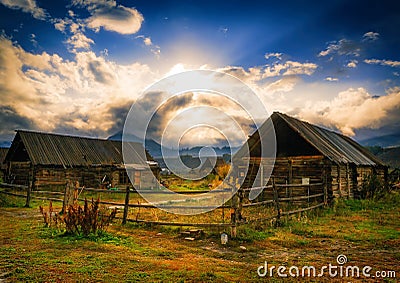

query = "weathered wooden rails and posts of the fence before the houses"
[0,178,328,239]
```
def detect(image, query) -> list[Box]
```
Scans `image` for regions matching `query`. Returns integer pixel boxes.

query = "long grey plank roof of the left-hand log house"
[6,130,151,168]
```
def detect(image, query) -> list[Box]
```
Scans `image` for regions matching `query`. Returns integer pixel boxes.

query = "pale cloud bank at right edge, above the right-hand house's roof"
[298,88,400,136]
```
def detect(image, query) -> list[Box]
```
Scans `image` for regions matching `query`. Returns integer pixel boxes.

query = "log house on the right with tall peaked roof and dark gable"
[234,112,387,199]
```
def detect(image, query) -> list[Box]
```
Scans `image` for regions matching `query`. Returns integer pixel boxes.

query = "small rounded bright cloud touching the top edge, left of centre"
[72,0,144,34]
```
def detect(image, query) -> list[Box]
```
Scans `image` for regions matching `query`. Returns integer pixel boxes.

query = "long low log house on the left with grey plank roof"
[5,130,159,191]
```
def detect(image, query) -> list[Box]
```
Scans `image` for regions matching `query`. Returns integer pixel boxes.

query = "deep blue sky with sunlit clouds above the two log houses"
[0,0,400,144]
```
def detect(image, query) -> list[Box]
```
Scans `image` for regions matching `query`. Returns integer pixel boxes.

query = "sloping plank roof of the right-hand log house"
[238,112,384,166]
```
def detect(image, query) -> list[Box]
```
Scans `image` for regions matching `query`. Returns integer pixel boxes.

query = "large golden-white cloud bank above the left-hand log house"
[0,37,159,139]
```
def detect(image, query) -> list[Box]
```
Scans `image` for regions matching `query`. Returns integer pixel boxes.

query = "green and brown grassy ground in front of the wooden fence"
[0,192,400,282]
